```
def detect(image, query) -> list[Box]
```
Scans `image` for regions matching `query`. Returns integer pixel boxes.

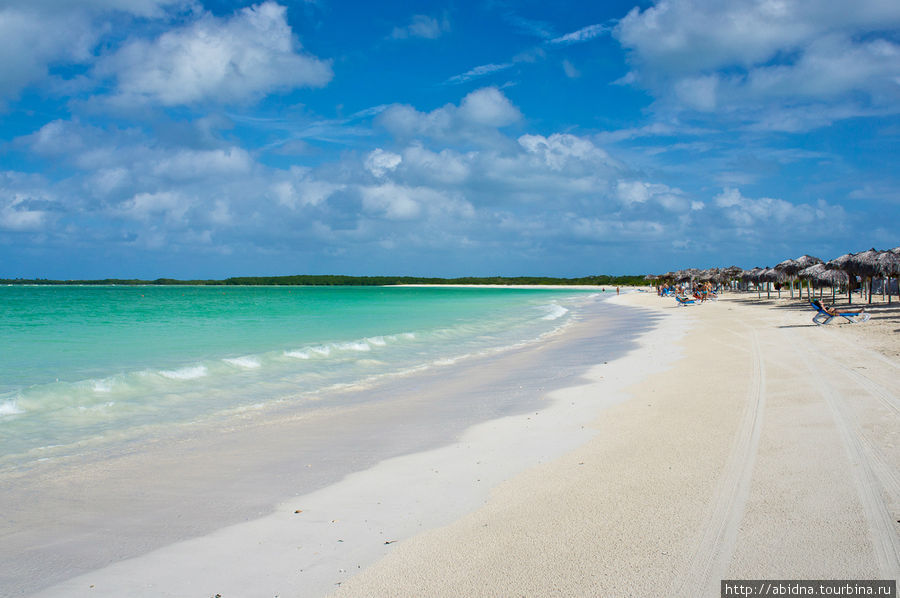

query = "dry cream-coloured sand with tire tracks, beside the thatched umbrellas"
[334,293,900,598]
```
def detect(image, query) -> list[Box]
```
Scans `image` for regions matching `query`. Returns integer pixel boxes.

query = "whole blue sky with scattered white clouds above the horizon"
[0,0,900,279]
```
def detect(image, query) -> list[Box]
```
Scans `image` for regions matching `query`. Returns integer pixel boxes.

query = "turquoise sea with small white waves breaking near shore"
[0,286,596,469]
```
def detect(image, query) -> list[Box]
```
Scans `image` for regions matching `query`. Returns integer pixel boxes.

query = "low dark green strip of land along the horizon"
[0,274,647,286]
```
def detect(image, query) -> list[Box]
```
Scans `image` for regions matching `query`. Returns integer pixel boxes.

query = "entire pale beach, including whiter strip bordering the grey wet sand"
[8,293,900,598]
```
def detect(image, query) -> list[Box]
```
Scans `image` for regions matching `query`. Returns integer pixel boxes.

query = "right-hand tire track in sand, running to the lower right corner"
[797,350,900,579]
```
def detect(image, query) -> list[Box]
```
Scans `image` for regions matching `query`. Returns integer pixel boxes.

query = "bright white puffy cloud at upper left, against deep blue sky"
[95,2,332,106]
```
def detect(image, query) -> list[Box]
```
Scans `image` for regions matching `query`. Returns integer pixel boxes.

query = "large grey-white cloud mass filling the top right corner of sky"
[614,0,900,130]
